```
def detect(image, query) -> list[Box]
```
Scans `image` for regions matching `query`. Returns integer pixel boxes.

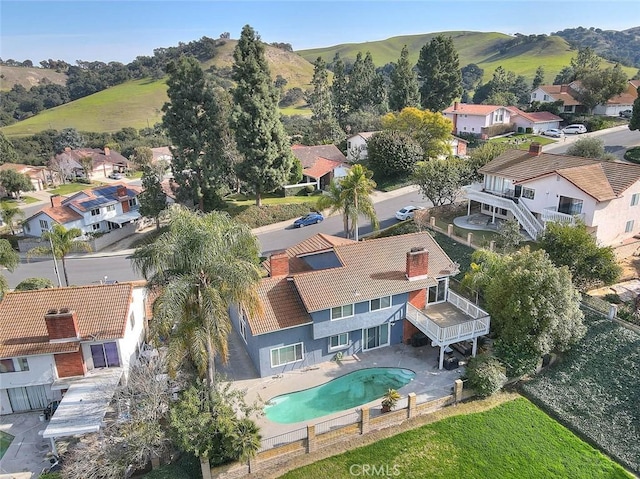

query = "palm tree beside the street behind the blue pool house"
[340,164,379,241]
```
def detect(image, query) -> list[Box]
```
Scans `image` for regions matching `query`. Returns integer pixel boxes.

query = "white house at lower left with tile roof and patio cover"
[0,283,147,451]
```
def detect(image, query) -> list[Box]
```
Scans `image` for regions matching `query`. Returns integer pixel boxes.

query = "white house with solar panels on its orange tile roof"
[23,182,142,237]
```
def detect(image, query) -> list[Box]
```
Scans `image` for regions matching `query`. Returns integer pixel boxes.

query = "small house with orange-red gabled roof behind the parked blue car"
[291,145,347,190]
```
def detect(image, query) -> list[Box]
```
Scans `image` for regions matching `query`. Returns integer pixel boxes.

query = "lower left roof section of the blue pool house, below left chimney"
[247,278,311,336]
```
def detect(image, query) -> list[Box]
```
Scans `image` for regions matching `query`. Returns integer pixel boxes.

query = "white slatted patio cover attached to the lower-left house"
[42,368,123,438]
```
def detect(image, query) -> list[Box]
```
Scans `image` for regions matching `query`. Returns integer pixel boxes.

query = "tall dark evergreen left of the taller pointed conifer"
[162,57,232,211]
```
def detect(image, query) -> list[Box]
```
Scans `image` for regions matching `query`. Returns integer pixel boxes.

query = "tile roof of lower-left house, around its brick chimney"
[0,283,133,358]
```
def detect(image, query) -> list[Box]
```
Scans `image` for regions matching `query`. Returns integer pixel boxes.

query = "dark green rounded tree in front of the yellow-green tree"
[367,130,424,178]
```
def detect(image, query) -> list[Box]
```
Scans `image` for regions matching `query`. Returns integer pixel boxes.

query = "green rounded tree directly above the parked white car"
[413,158,468,206]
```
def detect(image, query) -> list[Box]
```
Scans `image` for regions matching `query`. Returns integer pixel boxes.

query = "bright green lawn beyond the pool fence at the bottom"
[282,398,633,479]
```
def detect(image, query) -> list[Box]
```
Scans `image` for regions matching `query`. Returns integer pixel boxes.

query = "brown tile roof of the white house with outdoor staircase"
[479,150,640,201]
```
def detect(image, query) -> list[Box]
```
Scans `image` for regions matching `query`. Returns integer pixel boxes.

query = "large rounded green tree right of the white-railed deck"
[463,247,586,376]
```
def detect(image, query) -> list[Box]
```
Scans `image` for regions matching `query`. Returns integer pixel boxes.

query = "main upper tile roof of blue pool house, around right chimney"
[293,232,454,312]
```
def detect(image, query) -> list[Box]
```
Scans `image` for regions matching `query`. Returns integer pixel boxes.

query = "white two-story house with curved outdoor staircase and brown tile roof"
[464,143,640,246]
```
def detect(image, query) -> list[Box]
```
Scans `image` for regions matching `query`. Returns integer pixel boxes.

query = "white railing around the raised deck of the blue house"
[406,302,491,346]
